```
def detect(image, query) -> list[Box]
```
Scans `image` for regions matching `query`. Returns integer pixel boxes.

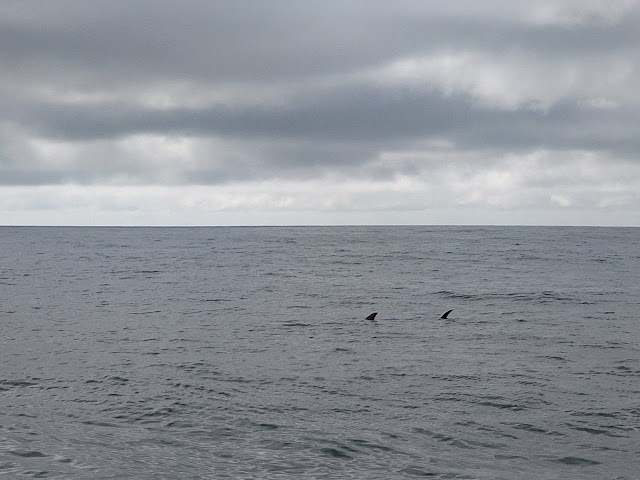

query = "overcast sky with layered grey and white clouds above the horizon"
[0,0,640,226]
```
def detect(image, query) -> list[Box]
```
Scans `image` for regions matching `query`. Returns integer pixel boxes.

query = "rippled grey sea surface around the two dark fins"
[0,227,640,480]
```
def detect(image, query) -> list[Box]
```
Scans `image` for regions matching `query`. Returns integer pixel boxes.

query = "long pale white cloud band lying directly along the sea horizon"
[0,151,640,225]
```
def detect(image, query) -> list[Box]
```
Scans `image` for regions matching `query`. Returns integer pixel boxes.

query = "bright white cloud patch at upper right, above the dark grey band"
[366,51,638,109]
